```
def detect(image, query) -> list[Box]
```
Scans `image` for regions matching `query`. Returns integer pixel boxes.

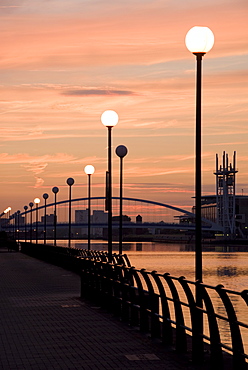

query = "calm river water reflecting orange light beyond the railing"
[51,240,248,291]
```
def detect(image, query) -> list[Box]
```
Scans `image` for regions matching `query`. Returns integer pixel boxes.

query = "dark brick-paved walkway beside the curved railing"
[0,249,198,370]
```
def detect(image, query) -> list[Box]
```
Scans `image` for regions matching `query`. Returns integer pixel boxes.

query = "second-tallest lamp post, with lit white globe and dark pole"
[101,110,119,260]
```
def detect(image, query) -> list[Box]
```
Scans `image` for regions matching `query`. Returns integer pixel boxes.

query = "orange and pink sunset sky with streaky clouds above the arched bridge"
[0,0,248,212]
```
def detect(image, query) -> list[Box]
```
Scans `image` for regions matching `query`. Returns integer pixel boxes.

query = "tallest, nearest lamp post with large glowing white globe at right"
[185,27,214,282]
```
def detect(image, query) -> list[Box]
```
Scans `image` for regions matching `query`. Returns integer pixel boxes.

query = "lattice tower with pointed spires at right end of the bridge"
[214,152,238,237]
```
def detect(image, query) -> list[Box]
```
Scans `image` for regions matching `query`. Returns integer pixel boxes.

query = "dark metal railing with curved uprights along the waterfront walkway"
[81,258,248,370]
